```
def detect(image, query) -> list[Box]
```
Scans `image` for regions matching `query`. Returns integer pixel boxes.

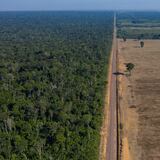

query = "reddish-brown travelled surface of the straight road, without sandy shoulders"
[106,14,117,160]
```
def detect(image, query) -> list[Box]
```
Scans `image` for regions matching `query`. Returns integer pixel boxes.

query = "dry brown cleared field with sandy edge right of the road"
[118,40,160,160]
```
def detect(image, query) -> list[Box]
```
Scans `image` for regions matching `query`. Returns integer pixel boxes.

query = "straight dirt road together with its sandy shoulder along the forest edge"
[100,13,117,160]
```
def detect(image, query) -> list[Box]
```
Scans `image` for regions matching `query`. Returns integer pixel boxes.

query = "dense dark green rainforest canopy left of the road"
[0,12,113,160]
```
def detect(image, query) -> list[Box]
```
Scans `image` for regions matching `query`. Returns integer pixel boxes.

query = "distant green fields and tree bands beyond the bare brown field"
[117,12,160,39]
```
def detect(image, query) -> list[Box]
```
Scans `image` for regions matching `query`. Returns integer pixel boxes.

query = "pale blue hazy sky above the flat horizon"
[0,0,160,11]
